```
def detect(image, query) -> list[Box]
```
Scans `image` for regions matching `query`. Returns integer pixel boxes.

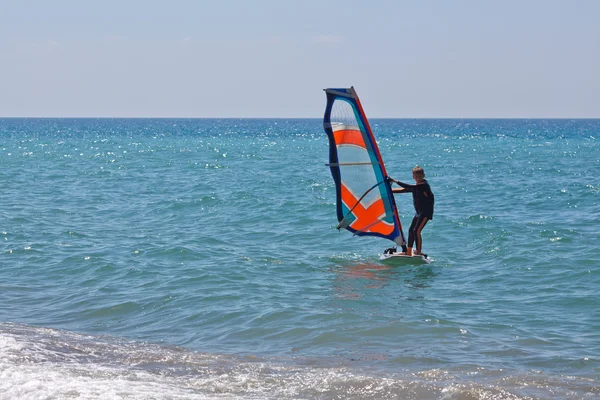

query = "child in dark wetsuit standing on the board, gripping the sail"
[391,165,434,256]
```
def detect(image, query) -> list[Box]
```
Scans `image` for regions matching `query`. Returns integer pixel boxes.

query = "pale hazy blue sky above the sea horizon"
[0,0,600,118]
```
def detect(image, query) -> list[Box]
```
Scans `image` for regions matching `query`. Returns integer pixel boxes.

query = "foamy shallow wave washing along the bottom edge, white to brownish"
[0,323,600,399]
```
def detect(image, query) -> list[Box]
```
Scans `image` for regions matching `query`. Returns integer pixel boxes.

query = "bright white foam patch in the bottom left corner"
[0,330,215,400]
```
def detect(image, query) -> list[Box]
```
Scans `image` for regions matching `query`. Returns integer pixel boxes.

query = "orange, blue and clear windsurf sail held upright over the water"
[323,87,406,246]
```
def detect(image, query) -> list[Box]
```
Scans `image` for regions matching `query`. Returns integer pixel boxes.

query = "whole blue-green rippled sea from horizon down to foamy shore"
[0,119,600,400]
